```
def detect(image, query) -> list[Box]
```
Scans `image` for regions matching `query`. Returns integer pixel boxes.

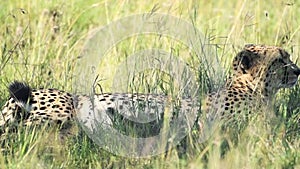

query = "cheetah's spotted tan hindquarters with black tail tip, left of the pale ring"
[0,82,75,132]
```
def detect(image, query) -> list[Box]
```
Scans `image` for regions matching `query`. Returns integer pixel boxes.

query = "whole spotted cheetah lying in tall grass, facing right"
[0,44,300,140]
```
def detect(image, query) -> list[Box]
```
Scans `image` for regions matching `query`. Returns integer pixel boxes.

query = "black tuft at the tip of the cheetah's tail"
[8,81,31,103]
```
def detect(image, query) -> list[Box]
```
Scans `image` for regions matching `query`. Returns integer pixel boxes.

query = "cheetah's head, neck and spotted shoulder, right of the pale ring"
[203,44,300,117]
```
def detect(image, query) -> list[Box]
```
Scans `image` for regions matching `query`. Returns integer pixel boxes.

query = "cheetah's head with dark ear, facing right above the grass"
[233,45,300,97]
